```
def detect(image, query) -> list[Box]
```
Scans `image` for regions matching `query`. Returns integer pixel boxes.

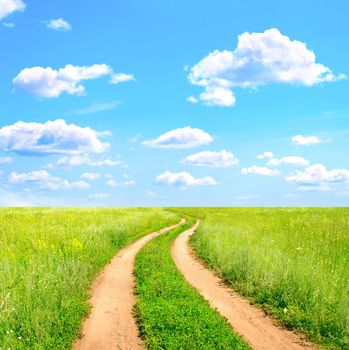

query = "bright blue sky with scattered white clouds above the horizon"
[0,0,349,206]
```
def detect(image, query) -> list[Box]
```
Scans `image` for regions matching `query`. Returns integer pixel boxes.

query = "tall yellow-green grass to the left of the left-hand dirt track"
[0,208,179,350]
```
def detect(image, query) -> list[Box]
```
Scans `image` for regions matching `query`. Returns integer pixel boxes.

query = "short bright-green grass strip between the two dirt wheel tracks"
[135,222,248,350]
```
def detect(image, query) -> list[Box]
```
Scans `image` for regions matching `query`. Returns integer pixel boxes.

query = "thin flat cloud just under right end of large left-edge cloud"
[53,154,127,168]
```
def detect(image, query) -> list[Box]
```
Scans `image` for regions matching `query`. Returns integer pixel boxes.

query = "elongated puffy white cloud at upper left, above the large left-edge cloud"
[13,64,112,98]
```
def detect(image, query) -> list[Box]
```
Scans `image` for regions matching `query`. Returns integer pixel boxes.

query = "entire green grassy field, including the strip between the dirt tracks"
[0,208,349,350]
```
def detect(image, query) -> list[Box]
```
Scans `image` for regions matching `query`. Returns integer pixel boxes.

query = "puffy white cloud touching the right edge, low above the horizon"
[285,164,349,191]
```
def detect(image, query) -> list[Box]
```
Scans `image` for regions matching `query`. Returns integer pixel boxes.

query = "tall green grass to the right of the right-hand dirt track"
[192,208,349,349]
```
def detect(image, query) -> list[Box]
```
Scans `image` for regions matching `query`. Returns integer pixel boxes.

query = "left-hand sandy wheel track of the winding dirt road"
[73,220,185,350]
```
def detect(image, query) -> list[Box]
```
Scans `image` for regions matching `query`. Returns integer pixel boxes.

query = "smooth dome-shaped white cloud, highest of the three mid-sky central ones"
[143,126,213,149]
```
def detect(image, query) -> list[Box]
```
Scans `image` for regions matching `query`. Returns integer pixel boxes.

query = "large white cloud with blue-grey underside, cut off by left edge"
[0,119,109,155]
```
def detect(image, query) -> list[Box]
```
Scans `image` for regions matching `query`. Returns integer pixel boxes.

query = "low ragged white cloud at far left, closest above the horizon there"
[8,170,90,191]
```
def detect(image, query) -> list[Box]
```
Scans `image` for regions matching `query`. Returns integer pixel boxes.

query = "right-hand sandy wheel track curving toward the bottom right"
[171,221,315,350]
